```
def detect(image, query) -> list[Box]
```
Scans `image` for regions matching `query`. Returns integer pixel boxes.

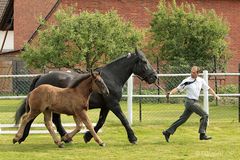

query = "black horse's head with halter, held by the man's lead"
[133,49,157,84]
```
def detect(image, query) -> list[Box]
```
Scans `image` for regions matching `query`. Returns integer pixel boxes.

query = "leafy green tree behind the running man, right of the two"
[150,0,230,72]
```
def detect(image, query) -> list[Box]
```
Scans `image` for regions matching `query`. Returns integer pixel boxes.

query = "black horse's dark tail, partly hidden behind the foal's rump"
[15,75,41,124]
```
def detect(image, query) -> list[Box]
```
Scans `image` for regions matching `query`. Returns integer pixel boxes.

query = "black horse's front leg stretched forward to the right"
[110,103,137,144]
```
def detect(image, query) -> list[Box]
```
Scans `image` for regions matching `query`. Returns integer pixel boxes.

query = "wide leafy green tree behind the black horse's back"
[22,7,143,69]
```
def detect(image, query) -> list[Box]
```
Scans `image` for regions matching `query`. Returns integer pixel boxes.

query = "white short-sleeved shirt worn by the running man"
[177,76,210,100]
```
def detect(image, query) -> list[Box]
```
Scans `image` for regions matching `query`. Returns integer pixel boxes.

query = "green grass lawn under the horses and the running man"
[0,100,240,160]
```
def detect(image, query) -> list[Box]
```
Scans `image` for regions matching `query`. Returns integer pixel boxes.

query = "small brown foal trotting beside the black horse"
[13,72,109,148]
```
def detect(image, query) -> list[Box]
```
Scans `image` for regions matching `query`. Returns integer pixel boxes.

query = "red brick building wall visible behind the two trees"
[14,0,240,72]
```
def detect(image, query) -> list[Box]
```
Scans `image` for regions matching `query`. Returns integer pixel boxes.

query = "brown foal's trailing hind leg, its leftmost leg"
[13,110,41,144]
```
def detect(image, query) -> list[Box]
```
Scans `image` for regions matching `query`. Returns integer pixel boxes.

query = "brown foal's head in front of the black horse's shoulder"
[91,70,109,95]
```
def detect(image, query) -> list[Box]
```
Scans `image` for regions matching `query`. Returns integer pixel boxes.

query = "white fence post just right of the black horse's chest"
[127,75,133,125]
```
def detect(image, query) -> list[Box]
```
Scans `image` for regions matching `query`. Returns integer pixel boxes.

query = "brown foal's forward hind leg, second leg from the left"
[43,110,64,148]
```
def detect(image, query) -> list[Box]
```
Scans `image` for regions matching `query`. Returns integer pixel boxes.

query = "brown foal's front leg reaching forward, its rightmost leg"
[79,110,105,146]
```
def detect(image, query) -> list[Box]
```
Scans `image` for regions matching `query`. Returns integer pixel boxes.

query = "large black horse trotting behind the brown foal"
[15,50,157,144]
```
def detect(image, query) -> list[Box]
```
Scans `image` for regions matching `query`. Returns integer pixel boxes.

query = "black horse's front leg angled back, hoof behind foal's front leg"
[83,107,109,143]
